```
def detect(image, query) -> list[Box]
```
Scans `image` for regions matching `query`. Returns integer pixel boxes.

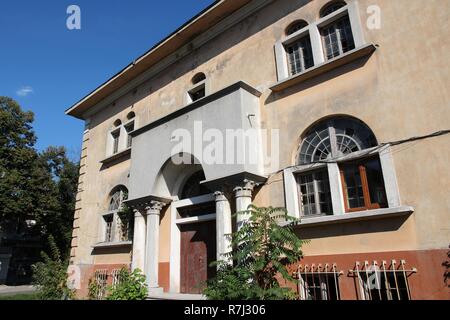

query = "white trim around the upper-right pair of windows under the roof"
[275,0,367,82]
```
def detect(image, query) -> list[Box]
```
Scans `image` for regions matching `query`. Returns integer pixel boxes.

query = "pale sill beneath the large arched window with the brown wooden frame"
[288,206,414,228]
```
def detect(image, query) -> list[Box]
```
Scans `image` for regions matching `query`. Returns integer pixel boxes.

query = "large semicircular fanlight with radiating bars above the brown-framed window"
[299,117,377,164]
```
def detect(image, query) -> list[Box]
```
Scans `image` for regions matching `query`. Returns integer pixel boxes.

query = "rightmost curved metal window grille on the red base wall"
[350,260,417,300]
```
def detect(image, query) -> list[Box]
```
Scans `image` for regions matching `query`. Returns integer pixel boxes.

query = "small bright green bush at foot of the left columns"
[106,268,148,300]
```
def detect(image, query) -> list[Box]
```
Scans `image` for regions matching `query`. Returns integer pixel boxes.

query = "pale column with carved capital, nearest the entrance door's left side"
[145,201,165,293]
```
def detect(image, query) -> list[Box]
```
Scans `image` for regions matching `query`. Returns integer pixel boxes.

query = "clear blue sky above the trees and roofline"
[0,0,213,160]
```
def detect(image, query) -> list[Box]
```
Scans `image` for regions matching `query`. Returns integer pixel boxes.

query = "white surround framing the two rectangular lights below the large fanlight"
[283,145,401,219]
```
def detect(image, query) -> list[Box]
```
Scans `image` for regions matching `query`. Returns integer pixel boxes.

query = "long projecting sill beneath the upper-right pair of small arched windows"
[270,44,376,92]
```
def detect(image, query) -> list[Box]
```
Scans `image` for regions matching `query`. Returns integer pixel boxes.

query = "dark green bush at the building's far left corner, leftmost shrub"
[33,236,74,300]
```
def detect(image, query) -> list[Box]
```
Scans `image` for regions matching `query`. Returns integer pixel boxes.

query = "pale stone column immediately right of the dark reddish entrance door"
[214,191,233,263]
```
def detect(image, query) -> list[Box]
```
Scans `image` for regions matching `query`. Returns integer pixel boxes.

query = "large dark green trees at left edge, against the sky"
[0,97,78,257]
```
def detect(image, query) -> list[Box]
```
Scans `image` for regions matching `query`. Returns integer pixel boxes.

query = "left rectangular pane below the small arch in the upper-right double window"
[286,35,314,75]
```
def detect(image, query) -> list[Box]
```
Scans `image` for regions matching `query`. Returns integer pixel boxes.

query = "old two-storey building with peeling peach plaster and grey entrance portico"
[67,0,450,300]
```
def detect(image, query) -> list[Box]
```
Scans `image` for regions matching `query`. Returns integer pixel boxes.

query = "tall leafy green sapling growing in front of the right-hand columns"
[204,206,305,300]
